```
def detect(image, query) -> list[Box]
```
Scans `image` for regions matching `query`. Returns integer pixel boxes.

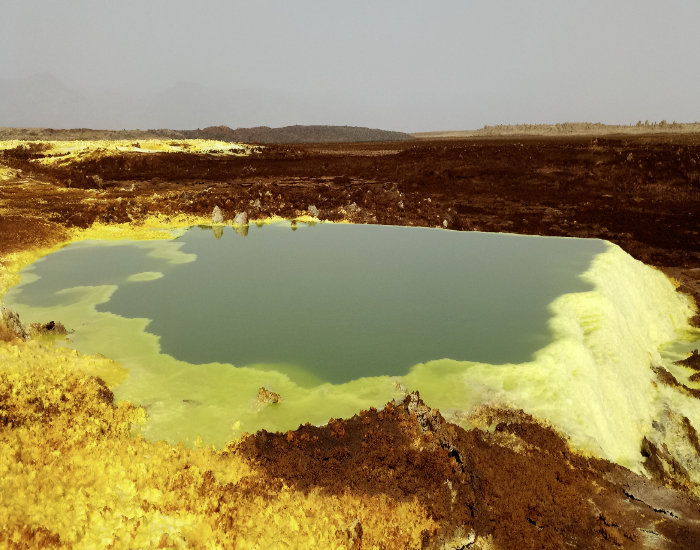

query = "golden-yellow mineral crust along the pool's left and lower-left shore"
[0,216,437,548]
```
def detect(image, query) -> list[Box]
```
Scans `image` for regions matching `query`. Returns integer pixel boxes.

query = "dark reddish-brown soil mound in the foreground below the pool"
[239,394,700,549]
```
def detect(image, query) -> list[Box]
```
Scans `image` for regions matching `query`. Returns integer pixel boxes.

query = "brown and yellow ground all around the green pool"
[0,123,700,549]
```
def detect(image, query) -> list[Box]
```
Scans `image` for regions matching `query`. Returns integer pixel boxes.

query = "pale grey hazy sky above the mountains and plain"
[0,0,700,131]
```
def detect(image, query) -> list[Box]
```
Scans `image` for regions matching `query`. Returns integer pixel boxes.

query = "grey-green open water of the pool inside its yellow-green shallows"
[8,224,605,384]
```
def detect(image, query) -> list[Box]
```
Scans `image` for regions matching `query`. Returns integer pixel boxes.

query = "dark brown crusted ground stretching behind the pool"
[0,134,700,272]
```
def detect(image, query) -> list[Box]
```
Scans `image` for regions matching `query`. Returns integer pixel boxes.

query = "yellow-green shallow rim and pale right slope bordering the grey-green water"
[6,222,700,476]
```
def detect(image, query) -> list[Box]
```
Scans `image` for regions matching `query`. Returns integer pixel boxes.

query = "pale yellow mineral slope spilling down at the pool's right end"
[403,244,700,481]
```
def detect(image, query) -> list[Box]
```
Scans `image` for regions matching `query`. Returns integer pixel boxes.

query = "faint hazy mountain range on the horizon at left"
[0,73,404,134]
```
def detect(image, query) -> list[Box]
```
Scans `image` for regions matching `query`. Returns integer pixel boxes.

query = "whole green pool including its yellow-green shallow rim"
[5,223,696,470]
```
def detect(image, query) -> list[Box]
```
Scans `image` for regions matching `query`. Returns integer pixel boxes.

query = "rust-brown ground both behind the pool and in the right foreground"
[0,134,700,548]
